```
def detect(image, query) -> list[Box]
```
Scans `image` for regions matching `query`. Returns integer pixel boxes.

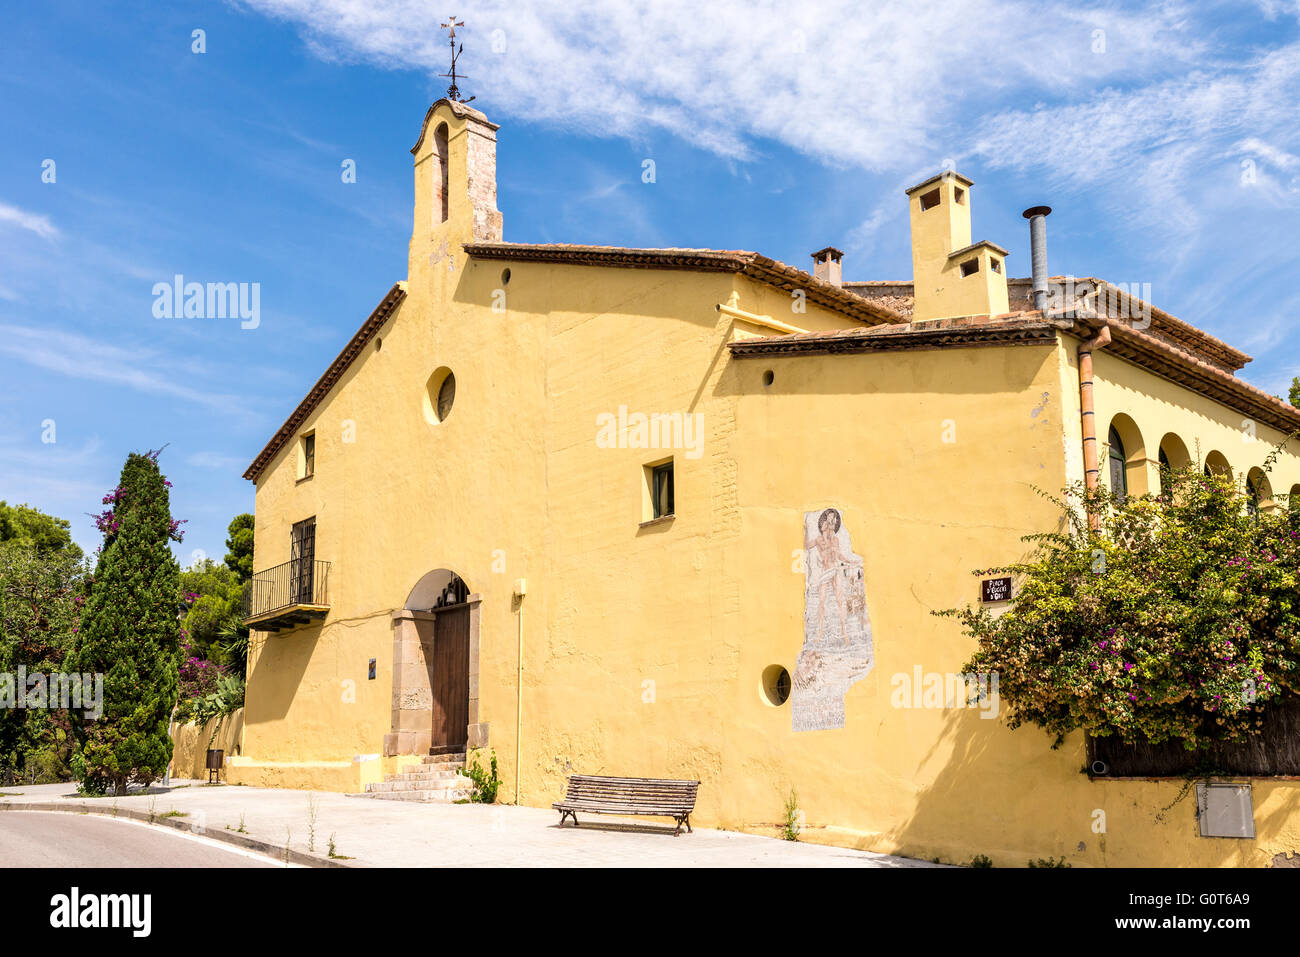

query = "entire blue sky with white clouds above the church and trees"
[0,0,1300,564]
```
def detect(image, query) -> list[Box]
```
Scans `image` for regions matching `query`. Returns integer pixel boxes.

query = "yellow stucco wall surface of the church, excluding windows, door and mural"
[239,100,1300,865]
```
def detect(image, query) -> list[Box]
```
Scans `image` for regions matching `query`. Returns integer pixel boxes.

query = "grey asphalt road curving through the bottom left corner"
[0,811,277,867]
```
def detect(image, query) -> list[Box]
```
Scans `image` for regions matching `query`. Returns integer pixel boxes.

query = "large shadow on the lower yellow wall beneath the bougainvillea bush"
[888,702,1300,867]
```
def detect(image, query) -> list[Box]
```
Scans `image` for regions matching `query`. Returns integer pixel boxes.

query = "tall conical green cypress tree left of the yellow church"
[70,452,181,794]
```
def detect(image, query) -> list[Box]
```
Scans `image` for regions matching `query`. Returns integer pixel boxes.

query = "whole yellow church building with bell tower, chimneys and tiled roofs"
[229,99,1300,866]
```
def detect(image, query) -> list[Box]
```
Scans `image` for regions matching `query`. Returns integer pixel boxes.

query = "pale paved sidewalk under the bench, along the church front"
[0,781,935,867]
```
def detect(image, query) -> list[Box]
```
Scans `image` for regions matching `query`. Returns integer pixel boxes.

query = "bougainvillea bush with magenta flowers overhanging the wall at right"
[939,468,1300,750]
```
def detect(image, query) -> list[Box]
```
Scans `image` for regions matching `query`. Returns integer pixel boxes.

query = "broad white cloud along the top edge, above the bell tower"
[243,0,1205,169]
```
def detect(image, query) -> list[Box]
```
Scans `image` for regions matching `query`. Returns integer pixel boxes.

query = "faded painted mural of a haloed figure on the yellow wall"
[790,508,875,731]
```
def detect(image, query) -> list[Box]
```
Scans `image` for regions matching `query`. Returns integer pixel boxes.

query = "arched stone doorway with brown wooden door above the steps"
[384,568,488,754]
